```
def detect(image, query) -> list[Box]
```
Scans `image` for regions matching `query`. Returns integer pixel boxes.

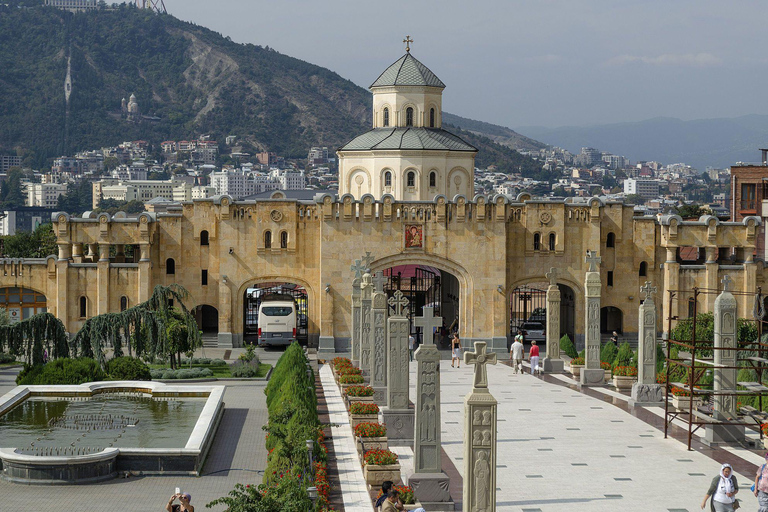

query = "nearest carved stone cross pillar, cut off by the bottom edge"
[462,341,497,512]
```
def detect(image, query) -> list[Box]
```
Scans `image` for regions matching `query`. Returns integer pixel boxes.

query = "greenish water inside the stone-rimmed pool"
[0,392,206,455]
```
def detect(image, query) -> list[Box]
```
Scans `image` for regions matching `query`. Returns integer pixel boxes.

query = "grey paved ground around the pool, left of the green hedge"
[0,366,270,512]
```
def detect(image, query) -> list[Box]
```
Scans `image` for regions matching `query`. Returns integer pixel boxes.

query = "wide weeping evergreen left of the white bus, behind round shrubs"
[72,284,203,366]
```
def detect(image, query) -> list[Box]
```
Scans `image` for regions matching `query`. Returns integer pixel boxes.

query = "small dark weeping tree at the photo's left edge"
[0,313,69,365]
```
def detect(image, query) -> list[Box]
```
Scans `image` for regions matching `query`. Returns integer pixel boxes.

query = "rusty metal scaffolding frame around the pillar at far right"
[664,288,768,450]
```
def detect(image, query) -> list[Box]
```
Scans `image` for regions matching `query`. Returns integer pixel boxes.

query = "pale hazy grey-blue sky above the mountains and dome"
[171,0,768,128]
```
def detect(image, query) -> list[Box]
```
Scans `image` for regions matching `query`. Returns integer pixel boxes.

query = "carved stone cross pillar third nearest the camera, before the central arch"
[381,290,414,446]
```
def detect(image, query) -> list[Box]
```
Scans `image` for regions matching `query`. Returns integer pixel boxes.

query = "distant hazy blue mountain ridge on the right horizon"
[518,115,768,171]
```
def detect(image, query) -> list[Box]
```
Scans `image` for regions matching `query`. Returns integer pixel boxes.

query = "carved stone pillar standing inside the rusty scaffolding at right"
[704,275,744,445]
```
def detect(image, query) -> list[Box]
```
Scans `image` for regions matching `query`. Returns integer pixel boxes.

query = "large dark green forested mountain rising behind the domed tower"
[0,0,538,172]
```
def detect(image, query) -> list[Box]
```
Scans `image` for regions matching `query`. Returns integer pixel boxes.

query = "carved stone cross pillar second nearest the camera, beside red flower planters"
[408,306,453,510]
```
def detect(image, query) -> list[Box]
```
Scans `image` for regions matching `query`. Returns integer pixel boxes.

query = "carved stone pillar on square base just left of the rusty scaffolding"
[630,281,664,405]
